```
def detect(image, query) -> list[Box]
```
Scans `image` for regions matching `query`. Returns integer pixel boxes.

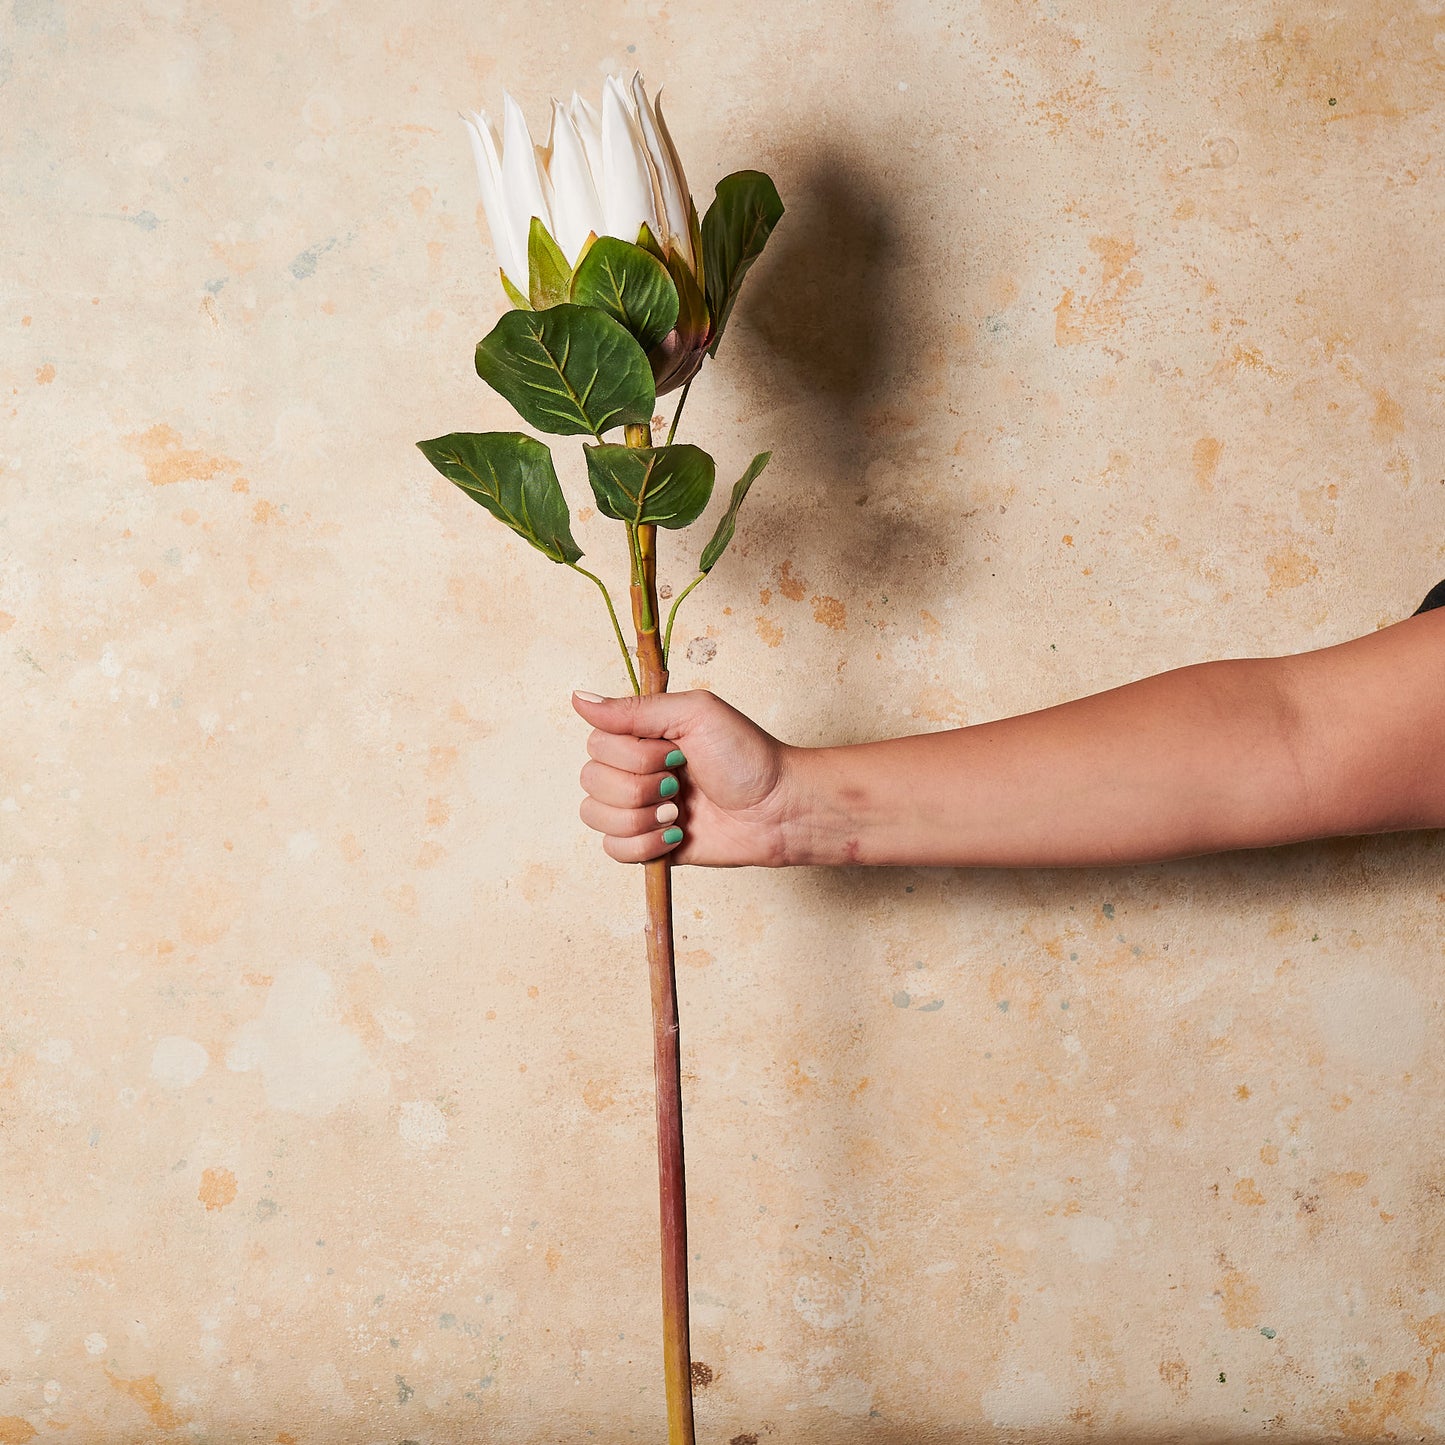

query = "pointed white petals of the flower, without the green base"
[462,74,698,293]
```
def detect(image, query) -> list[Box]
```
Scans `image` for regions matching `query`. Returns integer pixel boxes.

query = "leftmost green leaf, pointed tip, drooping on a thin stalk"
[416,432,582,566]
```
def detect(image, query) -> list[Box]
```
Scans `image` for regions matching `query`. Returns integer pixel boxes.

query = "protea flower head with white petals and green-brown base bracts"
[462,72,711,393]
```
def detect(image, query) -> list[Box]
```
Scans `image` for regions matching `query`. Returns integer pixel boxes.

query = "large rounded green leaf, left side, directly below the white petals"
[477,302,657,439]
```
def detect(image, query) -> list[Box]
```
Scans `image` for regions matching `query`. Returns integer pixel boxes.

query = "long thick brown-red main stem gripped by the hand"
[627,425,695,1445]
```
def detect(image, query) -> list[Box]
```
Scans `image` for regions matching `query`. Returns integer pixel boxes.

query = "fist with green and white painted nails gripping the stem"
[572,692,796,867]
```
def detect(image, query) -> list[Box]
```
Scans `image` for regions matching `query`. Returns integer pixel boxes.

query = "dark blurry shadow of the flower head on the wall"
[719,134,970,656]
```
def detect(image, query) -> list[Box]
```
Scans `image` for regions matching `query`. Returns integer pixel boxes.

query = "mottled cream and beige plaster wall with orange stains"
[0,0,1445,1445]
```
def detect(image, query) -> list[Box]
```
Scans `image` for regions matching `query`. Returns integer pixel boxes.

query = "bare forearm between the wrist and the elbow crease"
[785,659,1316,867]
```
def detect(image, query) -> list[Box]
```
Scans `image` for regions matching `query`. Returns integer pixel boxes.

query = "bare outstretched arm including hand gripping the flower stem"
[578,610,1445,867]
